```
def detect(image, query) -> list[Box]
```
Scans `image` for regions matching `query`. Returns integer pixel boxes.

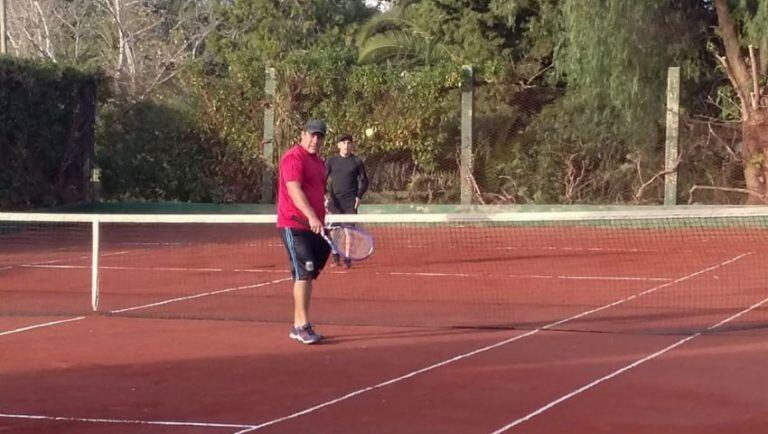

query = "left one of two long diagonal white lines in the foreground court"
[236,252,752,434]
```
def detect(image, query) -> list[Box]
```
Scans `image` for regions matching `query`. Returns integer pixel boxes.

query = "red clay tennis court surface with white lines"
[0,225,768,434]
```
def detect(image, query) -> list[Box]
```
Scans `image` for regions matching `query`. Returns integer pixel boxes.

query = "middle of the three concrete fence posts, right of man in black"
[459,65,475,205]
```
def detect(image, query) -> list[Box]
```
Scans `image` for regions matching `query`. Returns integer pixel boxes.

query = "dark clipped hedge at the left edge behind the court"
[0,57,101,209]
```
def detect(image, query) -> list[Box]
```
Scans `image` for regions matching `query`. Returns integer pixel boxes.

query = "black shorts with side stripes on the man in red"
[278,228,331,280]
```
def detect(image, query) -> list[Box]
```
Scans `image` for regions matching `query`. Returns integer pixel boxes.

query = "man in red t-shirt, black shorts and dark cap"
[277,120,331,344]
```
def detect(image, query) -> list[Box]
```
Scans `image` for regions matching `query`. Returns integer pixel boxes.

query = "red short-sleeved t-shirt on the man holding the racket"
[277,145,325,229]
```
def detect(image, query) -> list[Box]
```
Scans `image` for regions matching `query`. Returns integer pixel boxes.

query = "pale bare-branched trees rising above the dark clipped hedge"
[9,0,218,100]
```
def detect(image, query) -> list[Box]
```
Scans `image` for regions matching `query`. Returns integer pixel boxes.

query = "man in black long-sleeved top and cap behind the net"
[325,134,368,268]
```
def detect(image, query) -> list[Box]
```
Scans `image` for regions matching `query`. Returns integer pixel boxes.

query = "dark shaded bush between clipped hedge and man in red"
[97,102,263,202]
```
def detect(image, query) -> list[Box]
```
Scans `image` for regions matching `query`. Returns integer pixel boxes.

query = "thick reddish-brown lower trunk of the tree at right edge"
[741,107,768,204]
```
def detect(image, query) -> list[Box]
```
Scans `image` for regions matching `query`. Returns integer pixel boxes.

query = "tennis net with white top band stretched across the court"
[0,207,768,333]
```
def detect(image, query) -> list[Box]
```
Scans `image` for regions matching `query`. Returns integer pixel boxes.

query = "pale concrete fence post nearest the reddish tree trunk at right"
[664,66,680,205]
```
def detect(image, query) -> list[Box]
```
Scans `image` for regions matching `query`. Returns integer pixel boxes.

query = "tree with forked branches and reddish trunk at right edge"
[715,0,768,204]
